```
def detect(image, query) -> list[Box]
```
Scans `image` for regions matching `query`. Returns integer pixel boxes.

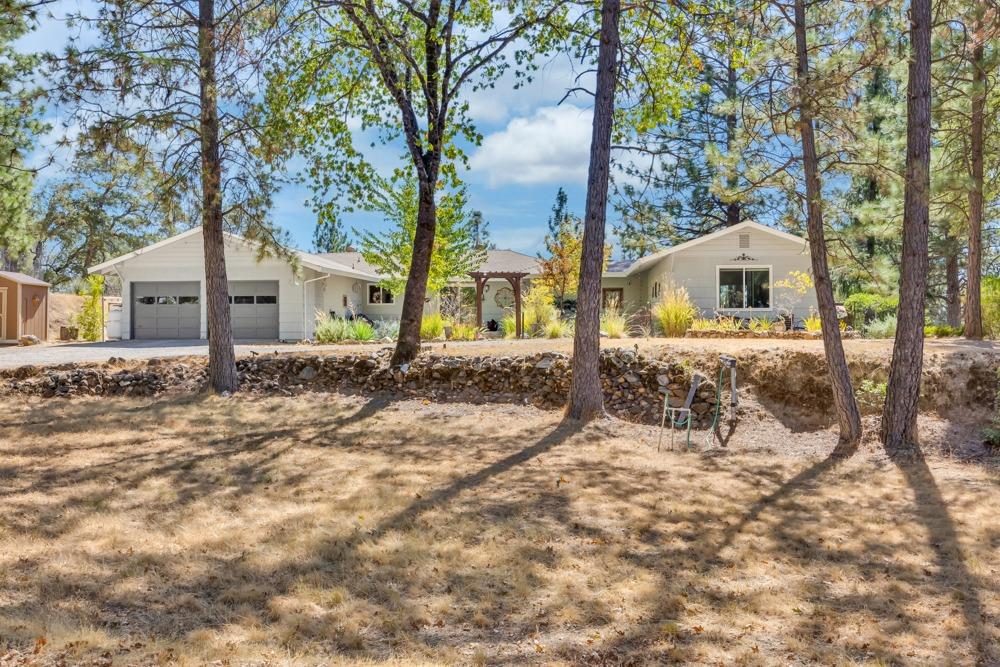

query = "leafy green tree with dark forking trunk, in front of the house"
[266,0,569,364]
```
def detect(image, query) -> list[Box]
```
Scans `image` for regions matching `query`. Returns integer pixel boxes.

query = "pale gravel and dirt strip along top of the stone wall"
[0,338,1000,368]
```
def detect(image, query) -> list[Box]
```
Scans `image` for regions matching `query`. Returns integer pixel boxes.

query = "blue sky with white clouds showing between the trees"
[20,0,600,254]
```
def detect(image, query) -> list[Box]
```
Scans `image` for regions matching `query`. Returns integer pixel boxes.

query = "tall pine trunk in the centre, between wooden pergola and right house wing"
[566,0,621,421]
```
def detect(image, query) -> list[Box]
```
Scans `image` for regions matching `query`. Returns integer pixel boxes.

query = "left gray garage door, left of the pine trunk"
[132,282,201,338]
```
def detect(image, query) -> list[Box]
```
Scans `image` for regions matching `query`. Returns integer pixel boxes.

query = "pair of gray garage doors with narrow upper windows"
[131,280,278,340]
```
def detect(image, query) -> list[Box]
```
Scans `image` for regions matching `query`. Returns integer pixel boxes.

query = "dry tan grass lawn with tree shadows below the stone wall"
[0,395,1000,665]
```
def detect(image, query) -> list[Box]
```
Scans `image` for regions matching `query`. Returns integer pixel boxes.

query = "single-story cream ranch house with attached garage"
[90,222,816,340]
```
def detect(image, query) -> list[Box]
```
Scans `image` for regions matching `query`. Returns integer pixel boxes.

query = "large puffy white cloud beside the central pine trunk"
[470,104,591,187]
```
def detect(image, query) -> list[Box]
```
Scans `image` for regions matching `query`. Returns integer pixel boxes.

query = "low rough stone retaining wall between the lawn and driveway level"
[0,349,716,424]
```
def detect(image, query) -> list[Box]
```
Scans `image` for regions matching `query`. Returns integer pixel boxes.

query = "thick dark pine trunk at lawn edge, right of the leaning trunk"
[881,0,931,453]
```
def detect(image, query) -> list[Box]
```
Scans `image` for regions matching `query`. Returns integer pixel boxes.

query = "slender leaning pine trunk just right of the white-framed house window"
[795,0,861,454]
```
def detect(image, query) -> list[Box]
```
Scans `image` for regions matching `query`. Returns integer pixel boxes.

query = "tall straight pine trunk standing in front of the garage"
[198,0,239,393]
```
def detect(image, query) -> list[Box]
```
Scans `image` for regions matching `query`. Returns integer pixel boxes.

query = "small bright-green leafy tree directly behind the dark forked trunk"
[354,178,486,294]
